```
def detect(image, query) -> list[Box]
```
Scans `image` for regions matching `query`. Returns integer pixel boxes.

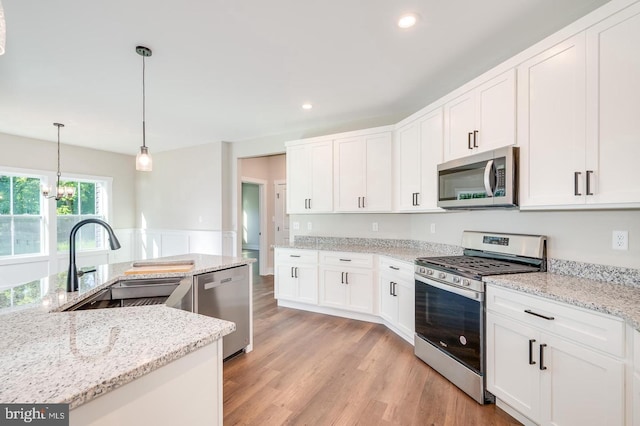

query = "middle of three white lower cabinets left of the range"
[319,252,375,314]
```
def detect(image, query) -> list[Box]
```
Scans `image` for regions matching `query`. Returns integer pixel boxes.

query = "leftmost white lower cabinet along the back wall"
[274,248,318,304]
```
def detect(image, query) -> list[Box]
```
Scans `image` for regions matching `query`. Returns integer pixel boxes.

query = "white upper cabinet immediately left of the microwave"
[394,108,443,211]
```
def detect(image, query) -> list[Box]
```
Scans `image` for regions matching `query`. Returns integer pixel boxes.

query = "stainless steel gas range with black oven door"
[415,231,547,404]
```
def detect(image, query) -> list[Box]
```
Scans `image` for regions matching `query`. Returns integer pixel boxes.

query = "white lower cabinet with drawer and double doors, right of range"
[486,285,626,426]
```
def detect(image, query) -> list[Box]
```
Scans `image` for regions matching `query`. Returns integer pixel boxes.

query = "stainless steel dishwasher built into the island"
[194,265,250,358]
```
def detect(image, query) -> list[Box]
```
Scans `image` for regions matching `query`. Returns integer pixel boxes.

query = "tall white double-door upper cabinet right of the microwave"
[518,4,640,208]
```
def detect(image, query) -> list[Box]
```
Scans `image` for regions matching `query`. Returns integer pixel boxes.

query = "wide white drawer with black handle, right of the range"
[486,285,625,357]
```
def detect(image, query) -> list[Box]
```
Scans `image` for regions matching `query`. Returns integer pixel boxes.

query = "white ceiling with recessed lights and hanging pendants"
[0,0,608,155]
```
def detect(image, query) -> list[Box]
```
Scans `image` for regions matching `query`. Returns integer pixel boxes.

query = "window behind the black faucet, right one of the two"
[56,180,106,252]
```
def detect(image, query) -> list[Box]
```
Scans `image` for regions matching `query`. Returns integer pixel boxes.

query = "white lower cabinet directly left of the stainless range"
[378,257,415,344]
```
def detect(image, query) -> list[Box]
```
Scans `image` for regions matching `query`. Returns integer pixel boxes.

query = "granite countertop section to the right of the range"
[484,272,640,331]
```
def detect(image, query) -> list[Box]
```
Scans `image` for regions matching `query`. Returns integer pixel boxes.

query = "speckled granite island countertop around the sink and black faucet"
[0,254,255,409]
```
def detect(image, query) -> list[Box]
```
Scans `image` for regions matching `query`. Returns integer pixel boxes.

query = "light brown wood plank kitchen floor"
[224,276,520,426]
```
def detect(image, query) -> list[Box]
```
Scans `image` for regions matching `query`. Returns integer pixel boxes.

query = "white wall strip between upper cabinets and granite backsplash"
[291,210,640,268]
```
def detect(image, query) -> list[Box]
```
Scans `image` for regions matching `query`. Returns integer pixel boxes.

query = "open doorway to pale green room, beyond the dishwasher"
[241,177,267,275]
